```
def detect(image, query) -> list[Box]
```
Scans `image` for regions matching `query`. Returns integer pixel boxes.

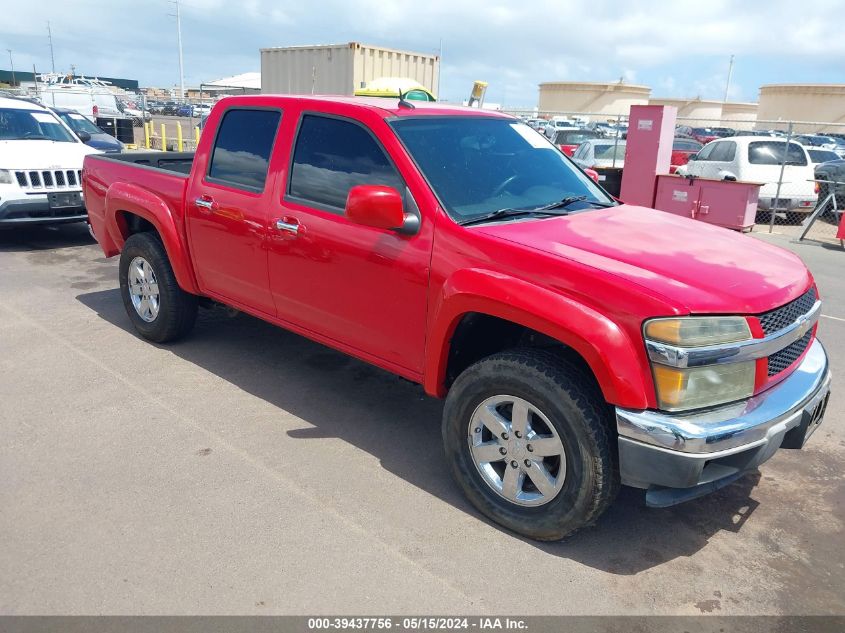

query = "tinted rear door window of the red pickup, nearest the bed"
[208,109,282,192]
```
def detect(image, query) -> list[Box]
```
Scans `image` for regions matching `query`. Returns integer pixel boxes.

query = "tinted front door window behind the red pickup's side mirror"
[288,114,405,210]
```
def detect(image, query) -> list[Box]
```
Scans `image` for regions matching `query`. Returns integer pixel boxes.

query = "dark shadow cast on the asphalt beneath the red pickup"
[77,289,759,575]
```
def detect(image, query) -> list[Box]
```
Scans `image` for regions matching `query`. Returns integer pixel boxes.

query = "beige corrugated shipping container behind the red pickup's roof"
[261,42,440,95]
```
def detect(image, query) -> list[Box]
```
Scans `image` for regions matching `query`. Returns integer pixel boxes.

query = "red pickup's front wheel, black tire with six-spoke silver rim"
[443,349,619,541]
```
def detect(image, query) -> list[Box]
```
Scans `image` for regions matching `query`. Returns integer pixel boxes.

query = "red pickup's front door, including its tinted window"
[269,113,433,374]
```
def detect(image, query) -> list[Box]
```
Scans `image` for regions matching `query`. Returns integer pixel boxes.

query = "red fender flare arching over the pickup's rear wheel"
[105,182,199,294]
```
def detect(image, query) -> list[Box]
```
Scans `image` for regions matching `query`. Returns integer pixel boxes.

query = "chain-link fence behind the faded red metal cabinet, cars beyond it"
[509,110,845,243]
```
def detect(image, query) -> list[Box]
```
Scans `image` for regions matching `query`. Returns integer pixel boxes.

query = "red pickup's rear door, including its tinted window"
[185,106,283,315]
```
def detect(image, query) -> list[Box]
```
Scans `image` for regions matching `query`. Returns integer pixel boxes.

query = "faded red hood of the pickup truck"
[477,205,812,314]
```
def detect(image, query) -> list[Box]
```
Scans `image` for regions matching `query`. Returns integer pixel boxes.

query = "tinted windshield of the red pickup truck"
[391,116,613,222]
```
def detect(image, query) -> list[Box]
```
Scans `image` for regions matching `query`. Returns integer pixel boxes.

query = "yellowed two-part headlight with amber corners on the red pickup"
[643,317,756,411]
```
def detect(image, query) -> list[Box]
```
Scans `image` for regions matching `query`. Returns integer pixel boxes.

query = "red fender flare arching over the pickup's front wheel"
[424,269,653,408]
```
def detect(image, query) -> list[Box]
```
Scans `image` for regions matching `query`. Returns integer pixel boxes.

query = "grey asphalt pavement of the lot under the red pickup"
[0,225,845,615]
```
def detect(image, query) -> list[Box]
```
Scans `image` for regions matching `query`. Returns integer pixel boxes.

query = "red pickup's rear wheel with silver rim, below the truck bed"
[118,233,197,343]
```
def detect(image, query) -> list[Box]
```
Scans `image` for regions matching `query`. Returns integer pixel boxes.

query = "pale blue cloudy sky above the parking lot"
[0,0,845,106]
